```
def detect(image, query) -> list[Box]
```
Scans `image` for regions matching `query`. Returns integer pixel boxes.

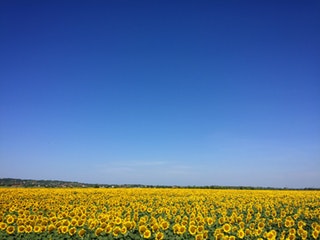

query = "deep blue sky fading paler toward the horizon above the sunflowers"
[0,0,320,187]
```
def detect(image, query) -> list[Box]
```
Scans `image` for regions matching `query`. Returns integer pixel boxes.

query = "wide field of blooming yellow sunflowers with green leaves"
[0,188,320,240]
